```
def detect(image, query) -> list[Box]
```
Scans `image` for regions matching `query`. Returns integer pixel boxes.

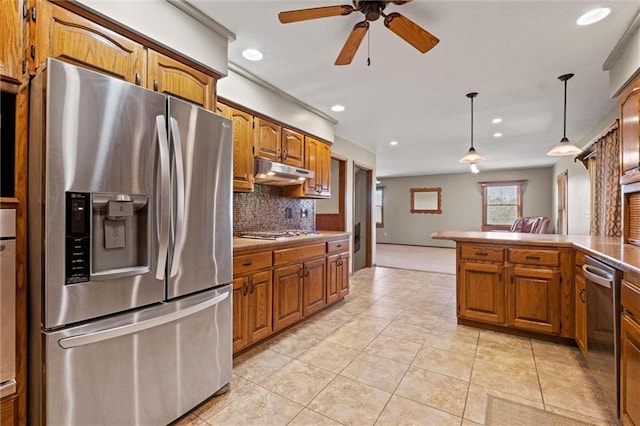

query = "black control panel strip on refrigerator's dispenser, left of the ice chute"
[65,192,91,284]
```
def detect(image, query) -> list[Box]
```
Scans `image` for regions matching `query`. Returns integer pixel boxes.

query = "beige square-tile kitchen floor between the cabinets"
[178,267,616,426]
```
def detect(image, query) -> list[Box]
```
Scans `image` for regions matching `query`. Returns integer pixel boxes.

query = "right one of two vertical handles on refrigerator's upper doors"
[169,117,185,277]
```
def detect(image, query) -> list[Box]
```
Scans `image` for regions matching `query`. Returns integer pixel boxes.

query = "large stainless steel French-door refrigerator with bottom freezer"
[28,59,232,425]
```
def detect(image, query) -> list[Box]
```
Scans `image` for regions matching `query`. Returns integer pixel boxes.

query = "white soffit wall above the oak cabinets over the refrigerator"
[76,0,228,75]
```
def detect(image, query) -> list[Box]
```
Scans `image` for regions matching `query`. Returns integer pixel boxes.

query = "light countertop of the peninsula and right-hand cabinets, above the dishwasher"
[431,231,640,274]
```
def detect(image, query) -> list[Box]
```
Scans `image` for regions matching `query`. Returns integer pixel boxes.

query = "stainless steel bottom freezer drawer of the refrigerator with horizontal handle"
[31,285,232,425]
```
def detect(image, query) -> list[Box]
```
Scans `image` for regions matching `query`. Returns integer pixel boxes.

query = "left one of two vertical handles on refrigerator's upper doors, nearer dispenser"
[155,115,171,280]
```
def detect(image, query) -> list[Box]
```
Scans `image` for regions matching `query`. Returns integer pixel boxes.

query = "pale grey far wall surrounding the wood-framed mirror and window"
[377,167,553,247]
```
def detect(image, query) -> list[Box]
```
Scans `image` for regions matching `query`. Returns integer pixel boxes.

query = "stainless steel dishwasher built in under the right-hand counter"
[582,256,622,417]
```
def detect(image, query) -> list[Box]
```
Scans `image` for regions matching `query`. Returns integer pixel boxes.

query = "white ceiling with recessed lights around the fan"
[190,0,640,177]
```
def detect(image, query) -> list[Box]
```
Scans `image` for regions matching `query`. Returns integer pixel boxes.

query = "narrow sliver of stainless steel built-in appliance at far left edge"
[0,209,16,398]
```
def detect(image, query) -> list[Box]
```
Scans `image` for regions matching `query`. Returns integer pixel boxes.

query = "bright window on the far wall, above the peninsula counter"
[481,180,526,231]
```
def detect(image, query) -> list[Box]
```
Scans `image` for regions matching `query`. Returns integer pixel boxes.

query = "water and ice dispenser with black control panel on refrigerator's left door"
[65,192,152,284]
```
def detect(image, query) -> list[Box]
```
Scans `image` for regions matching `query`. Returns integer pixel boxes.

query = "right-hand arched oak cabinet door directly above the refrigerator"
[147,50,216,110]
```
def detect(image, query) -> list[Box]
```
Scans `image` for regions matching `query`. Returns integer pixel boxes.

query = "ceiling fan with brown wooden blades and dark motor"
[278,0,440,65]
